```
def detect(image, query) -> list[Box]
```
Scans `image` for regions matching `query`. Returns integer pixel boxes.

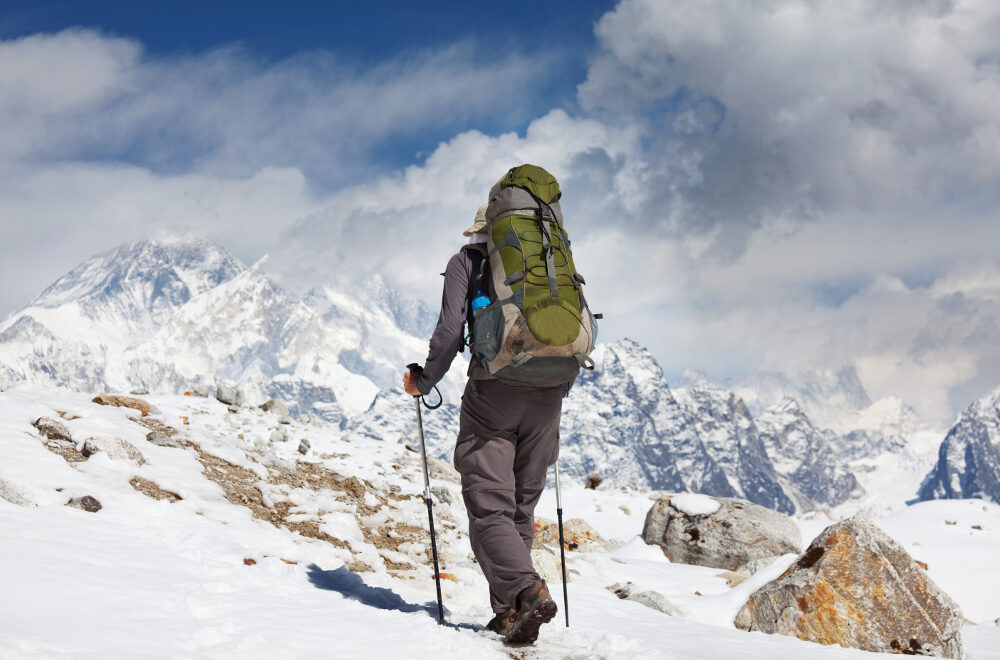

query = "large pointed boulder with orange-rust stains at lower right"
[735,514,963,658]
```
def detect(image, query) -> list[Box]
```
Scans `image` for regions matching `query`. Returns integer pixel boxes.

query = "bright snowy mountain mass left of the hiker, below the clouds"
[0,238,450,421]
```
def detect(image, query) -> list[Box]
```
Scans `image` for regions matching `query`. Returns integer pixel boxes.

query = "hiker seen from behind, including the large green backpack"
[403,165,596,643]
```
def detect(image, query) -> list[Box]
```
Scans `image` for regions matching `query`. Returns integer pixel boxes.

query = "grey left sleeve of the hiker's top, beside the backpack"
[417,250,471,394]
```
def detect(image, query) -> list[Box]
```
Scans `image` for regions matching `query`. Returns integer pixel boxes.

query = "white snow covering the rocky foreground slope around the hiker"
[0,384,1000,660]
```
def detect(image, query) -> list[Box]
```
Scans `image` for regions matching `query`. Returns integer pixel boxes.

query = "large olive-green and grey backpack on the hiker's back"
[470,165,599,387]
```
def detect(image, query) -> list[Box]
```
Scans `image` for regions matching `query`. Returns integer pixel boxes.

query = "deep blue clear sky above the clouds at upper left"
[0,0,614,178]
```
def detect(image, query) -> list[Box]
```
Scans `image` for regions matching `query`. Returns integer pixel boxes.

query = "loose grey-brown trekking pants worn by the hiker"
[455,380,565,613]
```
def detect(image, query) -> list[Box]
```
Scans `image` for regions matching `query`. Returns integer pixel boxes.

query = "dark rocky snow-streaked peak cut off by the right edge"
[919,388,1000,502]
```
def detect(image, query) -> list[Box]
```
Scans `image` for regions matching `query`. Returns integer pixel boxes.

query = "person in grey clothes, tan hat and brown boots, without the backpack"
[403,204,572,644]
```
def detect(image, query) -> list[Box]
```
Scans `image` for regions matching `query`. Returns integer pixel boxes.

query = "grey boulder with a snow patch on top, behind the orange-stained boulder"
[642,497,802,571]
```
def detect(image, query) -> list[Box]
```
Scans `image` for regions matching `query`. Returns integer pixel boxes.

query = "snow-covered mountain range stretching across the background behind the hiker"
[0,237,1000,516]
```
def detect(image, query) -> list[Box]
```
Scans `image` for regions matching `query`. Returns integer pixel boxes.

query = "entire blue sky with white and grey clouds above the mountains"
[0,0,1000,420]
